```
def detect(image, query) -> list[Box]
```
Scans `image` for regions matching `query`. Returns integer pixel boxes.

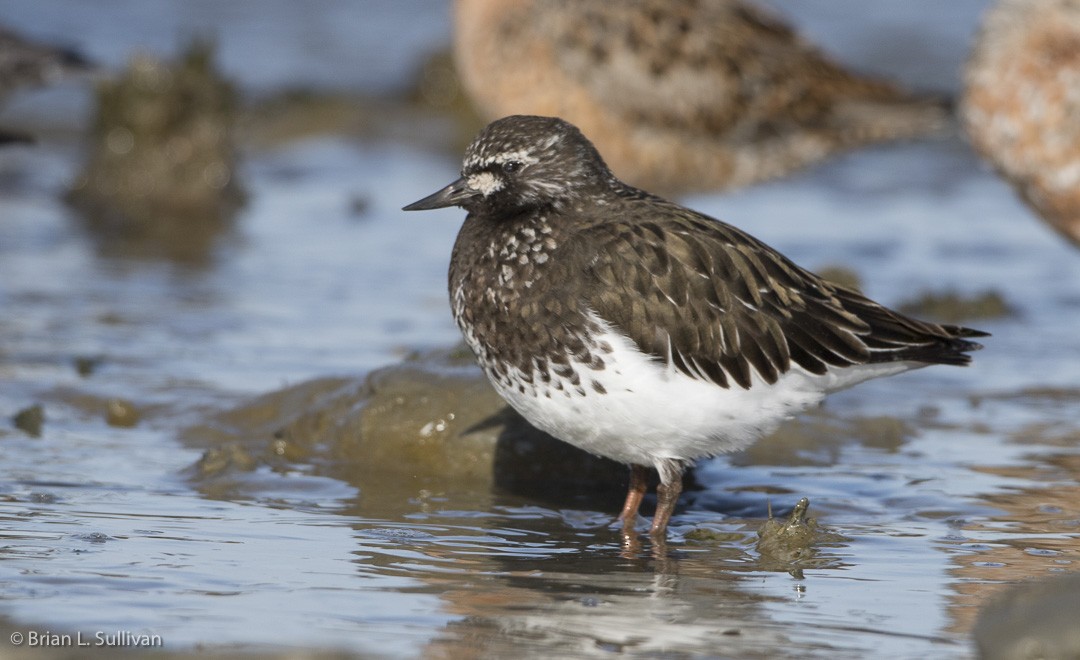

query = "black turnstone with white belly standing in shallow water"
[405,116,985,538]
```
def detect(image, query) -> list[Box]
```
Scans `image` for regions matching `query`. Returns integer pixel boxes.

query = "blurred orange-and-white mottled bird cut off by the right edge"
[961,0,1080,246]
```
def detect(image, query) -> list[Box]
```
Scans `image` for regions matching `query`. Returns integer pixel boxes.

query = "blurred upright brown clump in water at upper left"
[67,43,244,260]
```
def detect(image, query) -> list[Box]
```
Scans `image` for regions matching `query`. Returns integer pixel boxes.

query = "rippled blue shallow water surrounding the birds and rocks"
[0,2,1080,658]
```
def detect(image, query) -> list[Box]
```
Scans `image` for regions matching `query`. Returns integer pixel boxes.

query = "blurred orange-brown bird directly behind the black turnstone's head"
[455,0,946,191]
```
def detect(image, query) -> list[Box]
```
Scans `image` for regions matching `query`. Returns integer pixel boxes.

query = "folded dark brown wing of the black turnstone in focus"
[575,199,984,388]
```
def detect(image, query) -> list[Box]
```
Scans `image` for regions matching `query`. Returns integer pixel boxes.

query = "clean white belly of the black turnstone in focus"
[491,319,920,466]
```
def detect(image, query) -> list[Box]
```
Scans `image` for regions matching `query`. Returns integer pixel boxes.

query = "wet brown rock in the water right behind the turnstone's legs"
[185,351,626,501]
